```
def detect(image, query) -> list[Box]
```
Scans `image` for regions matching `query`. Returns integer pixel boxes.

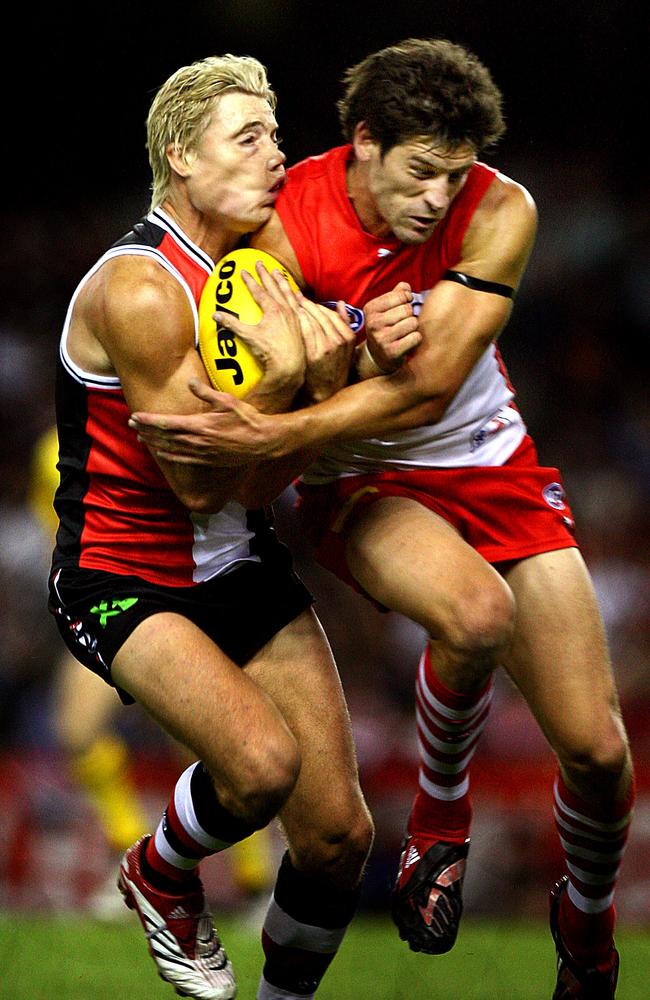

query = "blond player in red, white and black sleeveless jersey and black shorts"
[50,55,372,1000]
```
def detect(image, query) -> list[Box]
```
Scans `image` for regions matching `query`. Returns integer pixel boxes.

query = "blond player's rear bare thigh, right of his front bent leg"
[245,609,370,843]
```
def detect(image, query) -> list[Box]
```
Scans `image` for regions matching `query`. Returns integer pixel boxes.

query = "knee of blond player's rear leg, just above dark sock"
[291,801,375,889]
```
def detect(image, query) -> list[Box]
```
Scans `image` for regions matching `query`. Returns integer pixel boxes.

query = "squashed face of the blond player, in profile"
[182,91,286,233]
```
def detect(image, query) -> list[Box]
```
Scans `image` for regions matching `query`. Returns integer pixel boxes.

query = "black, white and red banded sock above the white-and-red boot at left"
[143,761,253,893]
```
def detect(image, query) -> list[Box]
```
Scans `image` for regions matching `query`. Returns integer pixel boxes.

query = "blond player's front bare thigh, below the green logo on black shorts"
[111,612,297,789]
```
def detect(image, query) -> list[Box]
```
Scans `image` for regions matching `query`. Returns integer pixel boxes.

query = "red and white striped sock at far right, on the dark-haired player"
[553,775,635,964]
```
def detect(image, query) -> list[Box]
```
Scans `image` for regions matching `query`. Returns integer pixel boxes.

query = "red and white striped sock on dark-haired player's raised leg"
[408,646,492,844]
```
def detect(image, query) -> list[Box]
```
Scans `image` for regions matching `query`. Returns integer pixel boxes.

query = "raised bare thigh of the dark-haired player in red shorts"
[346,497,512,637]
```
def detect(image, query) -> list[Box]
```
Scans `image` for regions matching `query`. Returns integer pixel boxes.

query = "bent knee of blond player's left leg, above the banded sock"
[212,731,301,829]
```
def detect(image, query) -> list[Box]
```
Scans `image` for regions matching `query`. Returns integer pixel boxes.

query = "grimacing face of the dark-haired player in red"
[366,138,476,243]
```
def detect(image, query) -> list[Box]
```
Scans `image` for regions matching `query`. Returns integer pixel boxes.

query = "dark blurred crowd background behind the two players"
[0,0,650,924]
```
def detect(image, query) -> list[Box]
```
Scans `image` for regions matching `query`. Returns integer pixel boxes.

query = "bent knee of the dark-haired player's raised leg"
[443,578,515,665]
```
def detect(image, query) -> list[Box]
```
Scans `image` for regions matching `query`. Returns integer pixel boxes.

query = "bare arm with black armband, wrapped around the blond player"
[129,175,537,466]
